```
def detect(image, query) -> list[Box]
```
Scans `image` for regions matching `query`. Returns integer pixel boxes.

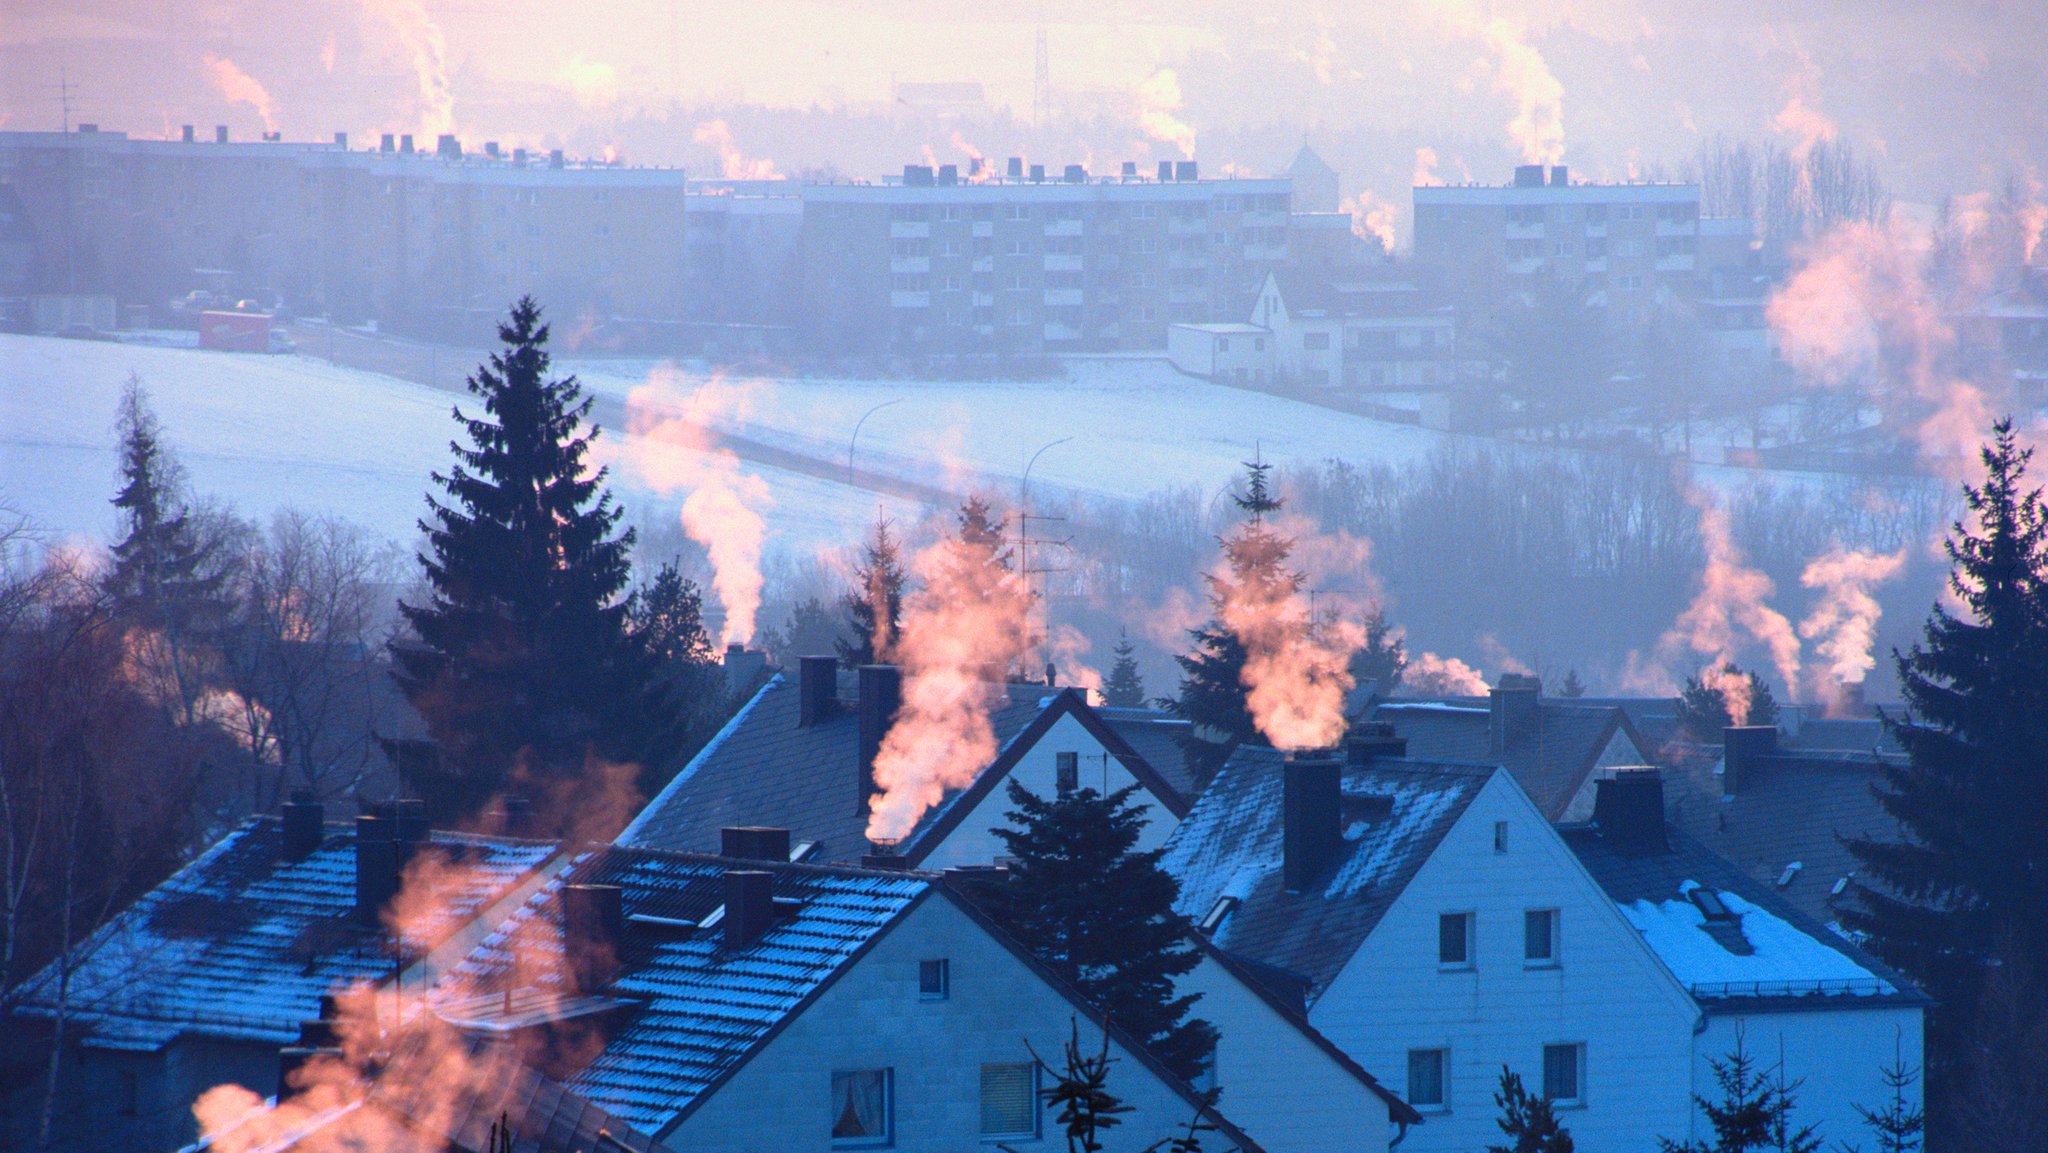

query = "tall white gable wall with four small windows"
[1309,772,1698,1153]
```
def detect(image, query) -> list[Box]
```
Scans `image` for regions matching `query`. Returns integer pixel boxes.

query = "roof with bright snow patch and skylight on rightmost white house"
[1559,823,1925,1012]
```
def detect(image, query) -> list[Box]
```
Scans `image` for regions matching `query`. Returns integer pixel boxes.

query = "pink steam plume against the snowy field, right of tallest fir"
[627,367,774,643]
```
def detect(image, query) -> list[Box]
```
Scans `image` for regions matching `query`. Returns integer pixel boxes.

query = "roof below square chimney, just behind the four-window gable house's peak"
[1372,700,1649,821]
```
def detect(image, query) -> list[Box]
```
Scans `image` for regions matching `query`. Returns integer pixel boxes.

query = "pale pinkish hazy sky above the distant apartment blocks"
[0,0,2048,195]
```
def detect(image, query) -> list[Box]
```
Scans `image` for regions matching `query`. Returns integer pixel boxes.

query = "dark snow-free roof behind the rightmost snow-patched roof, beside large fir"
[1671,756,1898,924]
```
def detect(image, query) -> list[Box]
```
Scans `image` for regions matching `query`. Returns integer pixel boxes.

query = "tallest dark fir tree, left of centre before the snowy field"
[391,297,676,817]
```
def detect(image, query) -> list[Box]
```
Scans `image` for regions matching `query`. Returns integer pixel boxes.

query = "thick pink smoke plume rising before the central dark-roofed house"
[868,518,1030,844]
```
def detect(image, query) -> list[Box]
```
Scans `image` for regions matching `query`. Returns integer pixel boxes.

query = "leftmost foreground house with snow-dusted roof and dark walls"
[6,801,559,1149]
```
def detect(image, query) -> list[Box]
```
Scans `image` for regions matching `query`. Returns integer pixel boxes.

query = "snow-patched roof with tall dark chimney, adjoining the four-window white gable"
[1161,745,1495,1003]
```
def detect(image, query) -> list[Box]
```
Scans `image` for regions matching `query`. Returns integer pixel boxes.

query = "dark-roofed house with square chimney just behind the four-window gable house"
[1372,672,1657,821]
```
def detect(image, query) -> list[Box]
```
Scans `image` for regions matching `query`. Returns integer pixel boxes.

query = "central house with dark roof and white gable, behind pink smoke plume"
[618,657,1192,868]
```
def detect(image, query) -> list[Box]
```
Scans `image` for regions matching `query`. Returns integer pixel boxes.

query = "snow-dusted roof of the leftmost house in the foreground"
[9,817,557,1049]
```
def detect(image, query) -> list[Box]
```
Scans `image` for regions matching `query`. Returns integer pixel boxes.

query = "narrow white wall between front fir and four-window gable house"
[1176,956,1397,1153]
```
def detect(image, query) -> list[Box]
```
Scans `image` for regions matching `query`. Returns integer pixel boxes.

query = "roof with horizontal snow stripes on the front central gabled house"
[438,846,932,1133]
